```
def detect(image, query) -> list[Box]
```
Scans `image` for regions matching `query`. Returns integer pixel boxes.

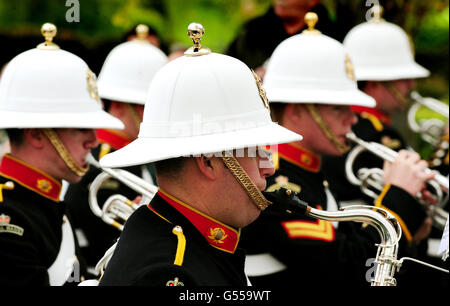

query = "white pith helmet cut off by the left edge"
[0,23,123,129]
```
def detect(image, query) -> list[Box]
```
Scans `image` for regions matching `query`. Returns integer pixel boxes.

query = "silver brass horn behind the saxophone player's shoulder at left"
[87,154,158,231]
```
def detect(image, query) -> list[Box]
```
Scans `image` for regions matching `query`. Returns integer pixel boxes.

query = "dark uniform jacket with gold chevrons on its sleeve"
[241,143,424,288]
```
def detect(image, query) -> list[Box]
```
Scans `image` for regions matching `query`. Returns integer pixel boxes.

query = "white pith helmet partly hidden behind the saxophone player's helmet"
[98,24,167,105]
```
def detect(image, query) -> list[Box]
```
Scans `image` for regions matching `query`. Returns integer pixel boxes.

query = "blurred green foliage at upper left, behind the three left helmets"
[0,0,271,52]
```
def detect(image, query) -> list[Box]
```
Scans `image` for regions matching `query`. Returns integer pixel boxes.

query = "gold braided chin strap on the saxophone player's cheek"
[222,153,272,210]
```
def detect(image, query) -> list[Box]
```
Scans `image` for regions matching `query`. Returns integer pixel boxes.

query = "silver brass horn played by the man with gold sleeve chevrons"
[345,132,449,230]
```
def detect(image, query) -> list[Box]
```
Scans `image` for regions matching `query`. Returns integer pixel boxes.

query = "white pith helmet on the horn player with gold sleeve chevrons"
[264,12,375,107]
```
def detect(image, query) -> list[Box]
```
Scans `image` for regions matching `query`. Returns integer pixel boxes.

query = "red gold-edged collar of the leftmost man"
[0,154,62,202]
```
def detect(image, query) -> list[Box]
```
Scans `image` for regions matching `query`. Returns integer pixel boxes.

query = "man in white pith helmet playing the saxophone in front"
[100,23,301,286]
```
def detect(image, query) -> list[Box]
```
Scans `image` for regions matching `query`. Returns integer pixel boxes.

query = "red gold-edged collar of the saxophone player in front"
[158,189,241,253]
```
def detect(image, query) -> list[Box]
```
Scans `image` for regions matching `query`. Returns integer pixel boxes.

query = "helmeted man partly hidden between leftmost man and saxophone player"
[64,24,167,267]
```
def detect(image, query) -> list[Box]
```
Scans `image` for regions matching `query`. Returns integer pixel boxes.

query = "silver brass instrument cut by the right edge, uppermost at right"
[407,91,449,146]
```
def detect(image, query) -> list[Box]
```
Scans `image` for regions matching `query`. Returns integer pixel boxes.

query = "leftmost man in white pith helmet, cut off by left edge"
[0,23,123,285]
